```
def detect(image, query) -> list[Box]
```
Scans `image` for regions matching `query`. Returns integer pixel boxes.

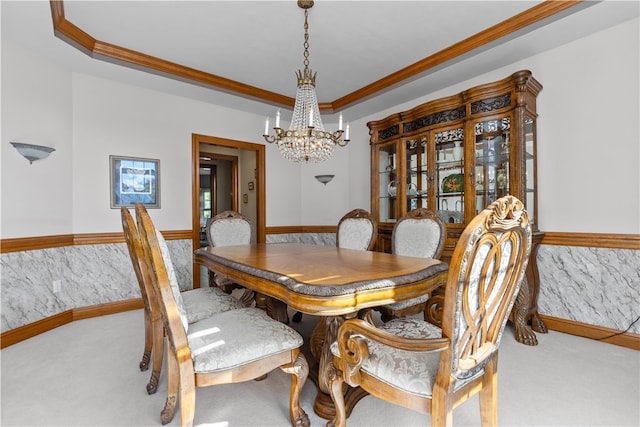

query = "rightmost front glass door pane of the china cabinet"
[474,117,511,214]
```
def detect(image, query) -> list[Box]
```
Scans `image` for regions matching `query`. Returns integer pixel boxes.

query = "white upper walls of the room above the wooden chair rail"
[1,19,640,238]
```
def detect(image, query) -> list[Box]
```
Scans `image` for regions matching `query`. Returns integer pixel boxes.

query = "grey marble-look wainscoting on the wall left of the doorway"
[0,240,193,332]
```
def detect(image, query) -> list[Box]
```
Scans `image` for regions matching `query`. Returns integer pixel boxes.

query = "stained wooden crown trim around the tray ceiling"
[50,0,583,112]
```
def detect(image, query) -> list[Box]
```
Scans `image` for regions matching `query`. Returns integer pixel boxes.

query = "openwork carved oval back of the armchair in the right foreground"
[438,196,531,381]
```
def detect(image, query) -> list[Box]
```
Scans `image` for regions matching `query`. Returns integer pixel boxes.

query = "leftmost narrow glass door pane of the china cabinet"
[378,142,399,226]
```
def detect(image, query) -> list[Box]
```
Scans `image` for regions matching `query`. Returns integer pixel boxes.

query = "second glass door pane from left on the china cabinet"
[405,136,428,212]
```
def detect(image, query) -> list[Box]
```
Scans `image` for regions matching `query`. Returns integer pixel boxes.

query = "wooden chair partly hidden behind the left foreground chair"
[120,207,245,394]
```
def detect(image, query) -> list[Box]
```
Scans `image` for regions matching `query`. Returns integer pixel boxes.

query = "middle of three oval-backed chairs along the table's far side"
[292,208,377,322]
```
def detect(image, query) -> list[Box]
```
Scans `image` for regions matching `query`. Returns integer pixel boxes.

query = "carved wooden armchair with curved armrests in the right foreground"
[326,196,531,426]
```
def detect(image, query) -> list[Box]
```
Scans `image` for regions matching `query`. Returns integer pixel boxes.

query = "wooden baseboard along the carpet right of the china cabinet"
[540,314,640,350]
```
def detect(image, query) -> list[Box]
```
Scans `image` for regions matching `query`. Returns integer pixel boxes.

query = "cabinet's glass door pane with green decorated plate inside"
[434,128,464,224]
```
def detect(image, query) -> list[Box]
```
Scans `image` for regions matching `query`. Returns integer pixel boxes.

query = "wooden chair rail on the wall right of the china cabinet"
[540,231,640,250]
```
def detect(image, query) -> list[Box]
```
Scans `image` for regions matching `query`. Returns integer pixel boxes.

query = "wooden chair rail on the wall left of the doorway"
[0,230,191,254]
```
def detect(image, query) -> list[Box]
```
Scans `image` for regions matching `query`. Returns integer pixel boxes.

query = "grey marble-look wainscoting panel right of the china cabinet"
[537,245,640,334]
